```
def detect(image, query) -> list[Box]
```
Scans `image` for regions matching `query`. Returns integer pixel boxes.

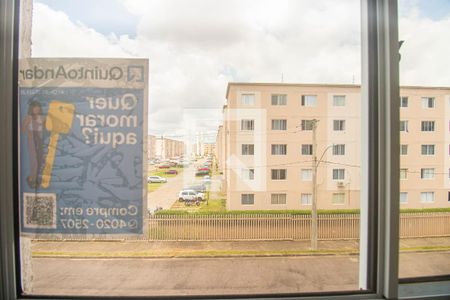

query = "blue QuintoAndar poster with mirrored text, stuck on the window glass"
[18,58,148,235]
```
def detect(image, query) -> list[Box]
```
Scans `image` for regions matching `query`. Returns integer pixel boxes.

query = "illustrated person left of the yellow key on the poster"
[22,100,45,188]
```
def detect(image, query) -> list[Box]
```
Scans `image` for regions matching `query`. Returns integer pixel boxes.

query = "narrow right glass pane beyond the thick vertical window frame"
[399,0,450,278]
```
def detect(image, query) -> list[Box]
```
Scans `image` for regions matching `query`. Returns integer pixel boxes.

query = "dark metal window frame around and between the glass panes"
[0,0,450,300]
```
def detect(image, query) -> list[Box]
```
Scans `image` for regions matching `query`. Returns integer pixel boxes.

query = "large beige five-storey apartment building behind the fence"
[215,83,450,210]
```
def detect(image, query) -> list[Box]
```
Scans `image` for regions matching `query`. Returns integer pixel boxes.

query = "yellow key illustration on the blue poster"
[41,101,75,189]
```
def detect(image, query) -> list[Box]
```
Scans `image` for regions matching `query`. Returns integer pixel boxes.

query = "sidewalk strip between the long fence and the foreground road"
[32,237,450,258]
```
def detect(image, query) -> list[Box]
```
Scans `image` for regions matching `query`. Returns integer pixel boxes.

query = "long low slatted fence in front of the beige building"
[148,212,450,241]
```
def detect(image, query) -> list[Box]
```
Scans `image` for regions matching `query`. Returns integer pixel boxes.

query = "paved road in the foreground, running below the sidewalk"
[29,252,450,296]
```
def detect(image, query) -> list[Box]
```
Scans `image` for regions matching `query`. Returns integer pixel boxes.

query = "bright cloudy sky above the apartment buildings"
[32,0,450,138]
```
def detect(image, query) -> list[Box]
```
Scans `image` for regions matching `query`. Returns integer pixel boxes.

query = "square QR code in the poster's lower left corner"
[23,193,56,228]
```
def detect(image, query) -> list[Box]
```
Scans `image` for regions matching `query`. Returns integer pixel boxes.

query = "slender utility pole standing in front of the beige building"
[311,119,319,250]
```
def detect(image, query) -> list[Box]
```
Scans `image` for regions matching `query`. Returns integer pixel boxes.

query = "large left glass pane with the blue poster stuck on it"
[18,0,368,297]
